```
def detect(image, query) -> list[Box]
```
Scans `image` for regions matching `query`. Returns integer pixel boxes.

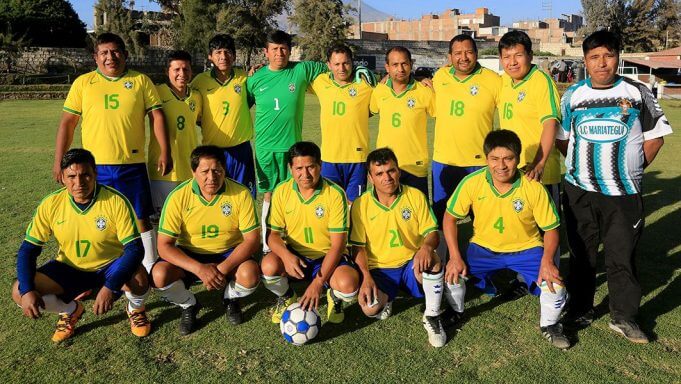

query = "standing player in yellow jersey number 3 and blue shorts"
[192,34,255,198]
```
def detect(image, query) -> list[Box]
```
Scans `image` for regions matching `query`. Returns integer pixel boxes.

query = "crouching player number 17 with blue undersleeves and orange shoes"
[12,149,151,342]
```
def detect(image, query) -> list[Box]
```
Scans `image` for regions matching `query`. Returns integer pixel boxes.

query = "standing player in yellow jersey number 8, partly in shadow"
[144,51,201,271]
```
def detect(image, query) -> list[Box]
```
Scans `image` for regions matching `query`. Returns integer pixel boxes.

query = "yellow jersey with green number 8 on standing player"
[147,84,201,181]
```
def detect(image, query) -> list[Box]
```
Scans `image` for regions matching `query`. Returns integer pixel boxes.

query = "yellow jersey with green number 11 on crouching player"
[267,178,349,259]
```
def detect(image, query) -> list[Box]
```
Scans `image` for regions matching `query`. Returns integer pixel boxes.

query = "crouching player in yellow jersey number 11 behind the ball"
[261,141,359,323]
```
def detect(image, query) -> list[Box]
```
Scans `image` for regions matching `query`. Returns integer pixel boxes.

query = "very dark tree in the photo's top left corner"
[0,0,87,47]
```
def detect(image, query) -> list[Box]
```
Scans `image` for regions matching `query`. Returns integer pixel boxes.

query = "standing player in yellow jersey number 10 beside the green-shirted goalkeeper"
[312,45,373,203]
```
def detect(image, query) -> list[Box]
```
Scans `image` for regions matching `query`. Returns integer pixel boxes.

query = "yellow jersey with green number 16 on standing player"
[497,65,561,185]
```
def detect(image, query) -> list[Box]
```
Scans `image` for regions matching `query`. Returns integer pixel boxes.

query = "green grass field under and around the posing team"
[0,97,681,383]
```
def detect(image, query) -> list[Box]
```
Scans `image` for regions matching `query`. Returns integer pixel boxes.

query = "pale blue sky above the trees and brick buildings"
[70,0,582,28]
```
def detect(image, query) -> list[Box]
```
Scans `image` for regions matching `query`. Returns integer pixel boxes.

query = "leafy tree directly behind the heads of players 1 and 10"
[289,0,352,61]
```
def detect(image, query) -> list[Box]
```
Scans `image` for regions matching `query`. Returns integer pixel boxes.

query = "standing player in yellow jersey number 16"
[497,31,560,297]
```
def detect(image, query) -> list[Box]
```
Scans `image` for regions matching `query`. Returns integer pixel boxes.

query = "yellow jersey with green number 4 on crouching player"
[447,167,560,252]
